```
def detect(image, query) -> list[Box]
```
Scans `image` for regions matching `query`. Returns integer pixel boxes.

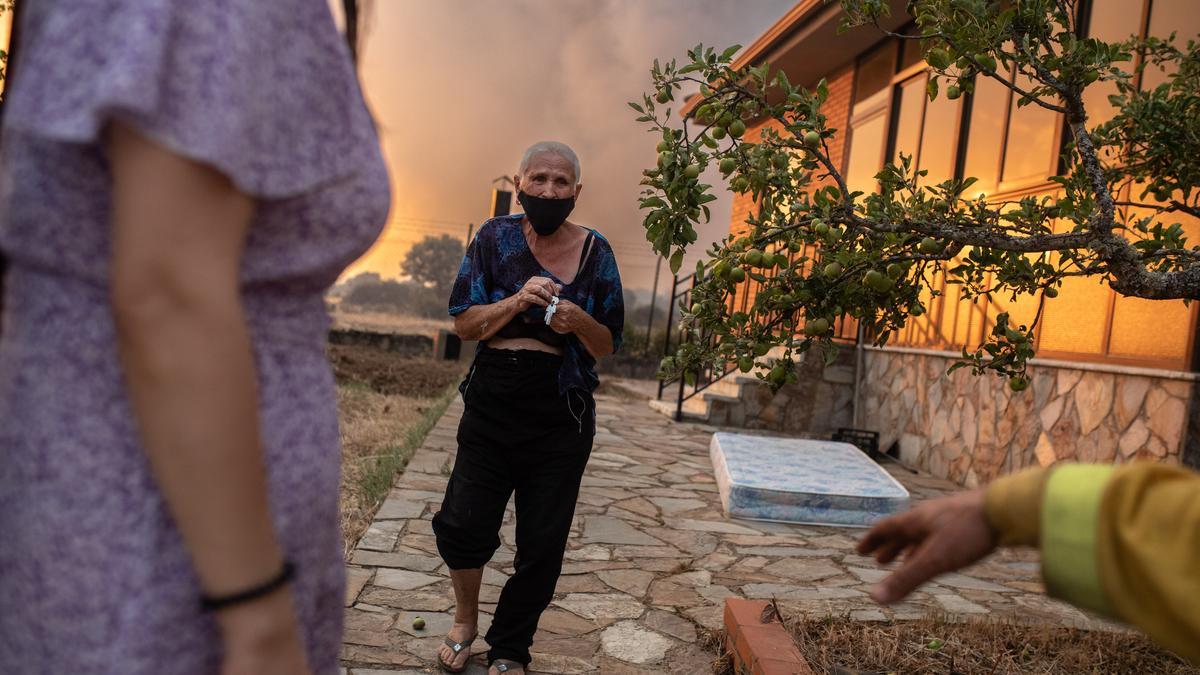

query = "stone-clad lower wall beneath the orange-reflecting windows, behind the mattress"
[860,350,1200,486]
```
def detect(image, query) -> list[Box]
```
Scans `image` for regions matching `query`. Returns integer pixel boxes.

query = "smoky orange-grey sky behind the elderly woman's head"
[336,0,794,288]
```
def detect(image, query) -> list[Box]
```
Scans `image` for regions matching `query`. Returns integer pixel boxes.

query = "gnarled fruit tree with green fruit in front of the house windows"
[630,0,1200,390]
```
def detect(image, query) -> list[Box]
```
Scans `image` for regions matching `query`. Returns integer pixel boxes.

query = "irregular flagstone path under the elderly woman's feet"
[342,396,1093,675]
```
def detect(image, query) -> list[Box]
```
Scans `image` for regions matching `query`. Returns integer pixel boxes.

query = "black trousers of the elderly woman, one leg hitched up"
[433,350,595,664]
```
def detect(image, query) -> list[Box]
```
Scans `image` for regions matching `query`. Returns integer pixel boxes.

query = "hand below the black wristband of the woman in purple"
[216,587,312,675]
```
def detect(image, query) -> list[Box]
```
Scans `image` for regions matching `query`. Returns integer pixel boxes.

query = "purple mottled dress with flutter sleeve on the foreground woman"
[0,0,389,675]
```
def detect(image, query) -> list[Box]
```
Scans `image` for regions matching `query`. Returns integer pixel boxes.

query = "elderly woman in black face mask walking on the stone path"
[433,142,624,674]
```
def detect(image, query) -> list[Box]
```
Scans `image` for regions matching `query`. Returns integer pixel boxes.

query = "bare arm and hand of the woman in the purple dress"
[108,125,306,673]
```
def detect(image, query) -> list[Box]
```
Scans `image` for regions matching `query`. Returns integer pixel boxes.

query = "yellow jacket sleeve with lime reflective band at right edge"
[986,462,1200,664]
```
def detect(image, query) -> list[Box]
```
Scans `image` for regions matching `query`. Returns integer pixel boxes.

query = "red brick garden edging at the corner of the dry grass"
[725,598,814,675]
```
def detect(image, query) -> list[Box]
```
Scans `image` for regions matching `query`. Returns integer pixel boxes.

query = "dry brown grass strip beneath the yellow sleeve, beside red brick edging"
[787,616,1200,675]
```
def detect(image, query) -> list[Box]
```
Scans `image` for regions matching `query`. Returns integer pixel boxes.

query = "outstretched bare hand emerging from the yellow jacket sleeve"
[858,490,998,604]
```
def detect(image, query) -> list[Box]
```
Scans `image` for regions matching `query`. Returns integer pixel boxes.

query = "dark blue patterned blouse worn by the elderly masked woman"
[450,214,625,394]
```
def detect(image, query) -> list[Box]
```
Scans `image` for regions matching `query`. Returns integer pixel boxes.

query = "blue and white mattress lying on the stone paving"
[709,431,908,527]
